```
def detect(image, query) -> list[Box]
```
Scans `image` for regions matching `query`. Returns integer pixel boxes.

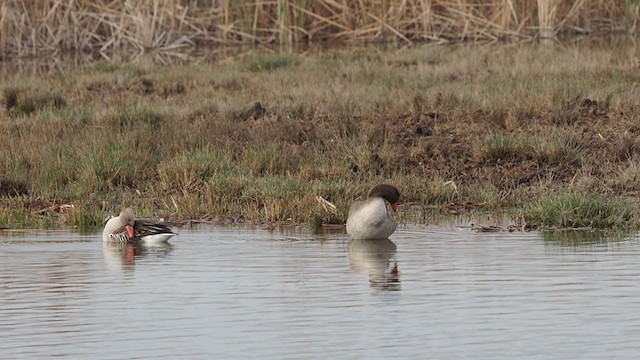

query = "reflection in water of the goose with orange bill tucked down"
[102,242,173,273]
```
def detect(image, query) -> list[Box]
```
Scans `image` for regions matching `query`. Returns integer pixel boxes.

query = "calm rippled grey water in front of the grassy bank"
[0,226,640,359]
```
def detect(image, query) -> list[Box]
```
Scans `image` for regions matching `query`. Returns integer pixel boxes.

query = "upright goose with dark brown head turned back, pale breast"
[347,184,400,240]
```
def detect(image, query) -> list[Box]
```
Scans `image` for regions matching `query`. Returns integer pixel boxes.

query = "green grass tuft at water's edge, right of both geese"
[523,192,637,230]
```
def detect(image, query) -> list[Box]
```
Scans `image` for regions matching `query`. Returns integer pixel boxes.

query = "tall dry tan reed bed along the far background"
[0,0,638,56]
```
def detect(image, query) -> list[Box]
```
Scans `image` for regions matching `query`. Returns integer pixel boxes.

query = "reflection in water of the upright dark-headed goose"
[347,239,400,291]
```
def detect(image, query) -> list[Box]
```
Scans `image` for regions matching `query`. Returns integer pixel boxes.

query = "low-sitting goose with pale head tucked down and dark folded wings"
[102,208,177,244]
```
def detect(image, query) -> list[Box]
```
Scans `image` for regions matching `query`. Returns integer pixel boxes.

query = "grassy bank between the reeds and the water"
[0,40,640,231]
